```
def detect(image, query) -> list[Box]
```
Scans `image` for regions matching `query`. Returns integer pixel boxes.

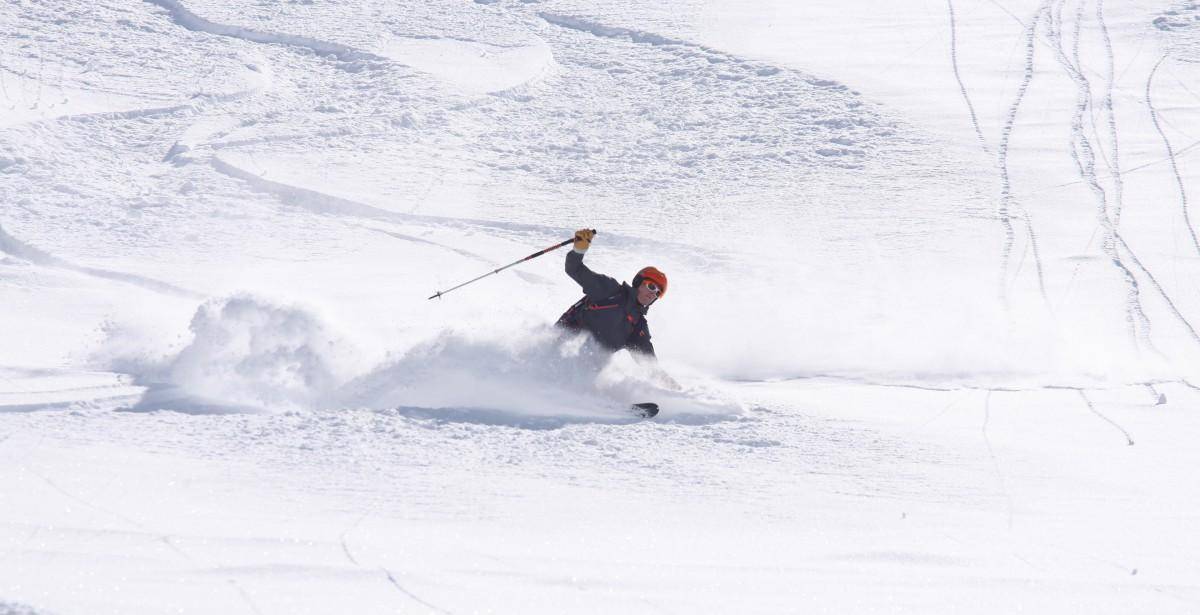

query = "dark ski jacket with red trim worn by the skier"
[558,250,654,357]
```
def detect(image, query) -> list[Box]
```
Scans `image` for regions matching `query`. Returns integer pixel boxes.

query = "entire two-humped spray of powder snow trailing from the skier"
[110,295,738,426]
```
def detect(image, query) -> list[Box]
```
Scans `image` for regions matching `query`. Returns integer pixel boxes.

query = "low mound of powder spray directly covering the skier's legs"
[338,327,738,426]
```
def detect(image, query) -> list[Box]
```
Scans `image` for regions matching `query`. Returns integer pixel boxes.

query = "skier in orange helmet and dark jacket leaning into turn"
[557,228,667,363]
